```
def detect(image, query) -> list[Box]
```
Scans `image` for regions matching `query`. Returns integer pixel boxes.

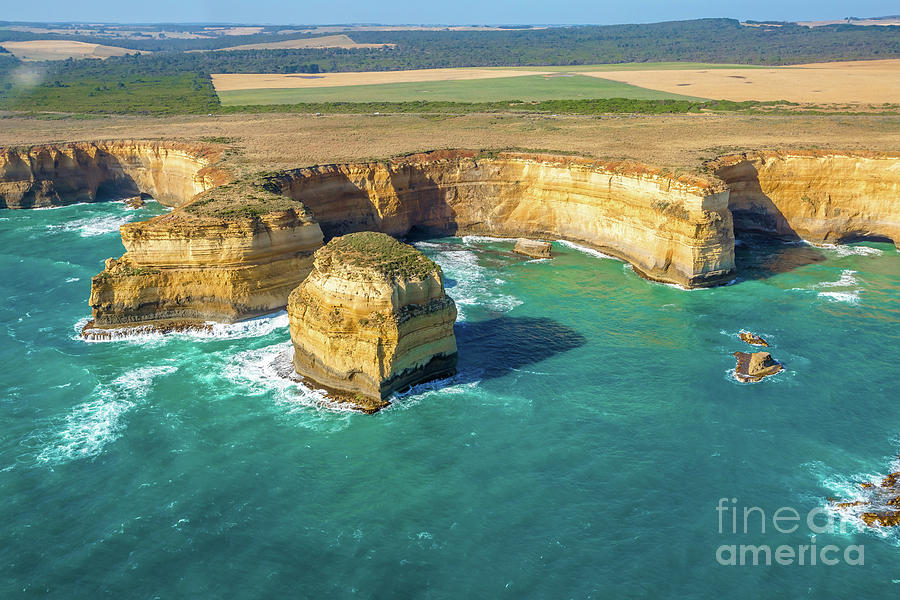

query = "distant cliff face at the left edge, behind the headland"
[0,141,226,208]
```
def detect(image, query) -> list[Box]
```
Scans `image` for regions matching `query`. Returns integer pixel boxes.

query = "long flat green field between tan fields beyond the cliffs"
[219,74,697,106]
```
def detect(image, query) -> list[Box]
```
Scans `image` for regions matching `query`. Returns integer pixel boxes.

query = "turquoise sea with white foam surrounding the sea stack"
[0,203,900,598]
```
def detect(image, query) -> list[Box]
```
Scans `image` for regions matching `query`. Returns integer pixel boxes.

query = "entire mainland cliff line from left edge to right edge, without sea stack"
[0,142,900,336]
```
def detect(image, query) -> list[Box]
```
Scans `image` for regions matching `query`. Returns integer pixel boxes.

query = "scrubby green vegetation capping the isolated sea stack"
[316,231,439,279]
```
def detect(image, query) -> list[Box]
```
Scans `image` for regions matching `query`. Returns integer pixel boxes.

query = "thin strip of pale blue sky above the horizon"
[0,0,900,25]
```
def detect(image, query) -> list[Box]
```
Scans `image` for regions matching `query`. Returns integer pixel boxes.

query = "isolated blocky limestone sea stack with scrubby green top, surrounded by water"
[288,232,456,412]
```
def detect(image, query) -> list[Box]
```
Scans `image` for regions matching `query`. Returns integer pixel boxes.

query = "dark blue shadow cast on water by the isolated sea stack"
[454,317,587,383]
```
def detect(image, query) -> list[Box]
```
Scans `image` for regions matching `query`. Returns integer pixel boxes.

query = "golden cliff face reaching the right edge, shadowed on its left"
[709,151,900,245]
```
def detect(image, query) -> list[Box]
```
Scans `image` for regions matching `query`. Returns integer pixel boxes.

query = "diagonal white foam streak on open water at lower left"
[37,365,178,463]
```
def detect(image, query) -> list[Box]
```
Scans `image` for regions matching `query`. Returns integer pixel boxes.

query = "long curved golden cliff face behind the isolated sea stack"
[284,152,734,287]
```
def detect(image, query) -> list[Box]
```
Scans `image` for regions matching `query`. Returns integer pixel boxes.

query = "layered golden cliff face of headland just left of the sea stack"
[85,210,322,335]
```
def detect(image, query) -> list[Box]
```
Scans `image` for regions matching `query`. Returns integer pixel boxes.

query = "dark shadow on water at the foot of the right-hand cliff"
[734,234,825,279]
